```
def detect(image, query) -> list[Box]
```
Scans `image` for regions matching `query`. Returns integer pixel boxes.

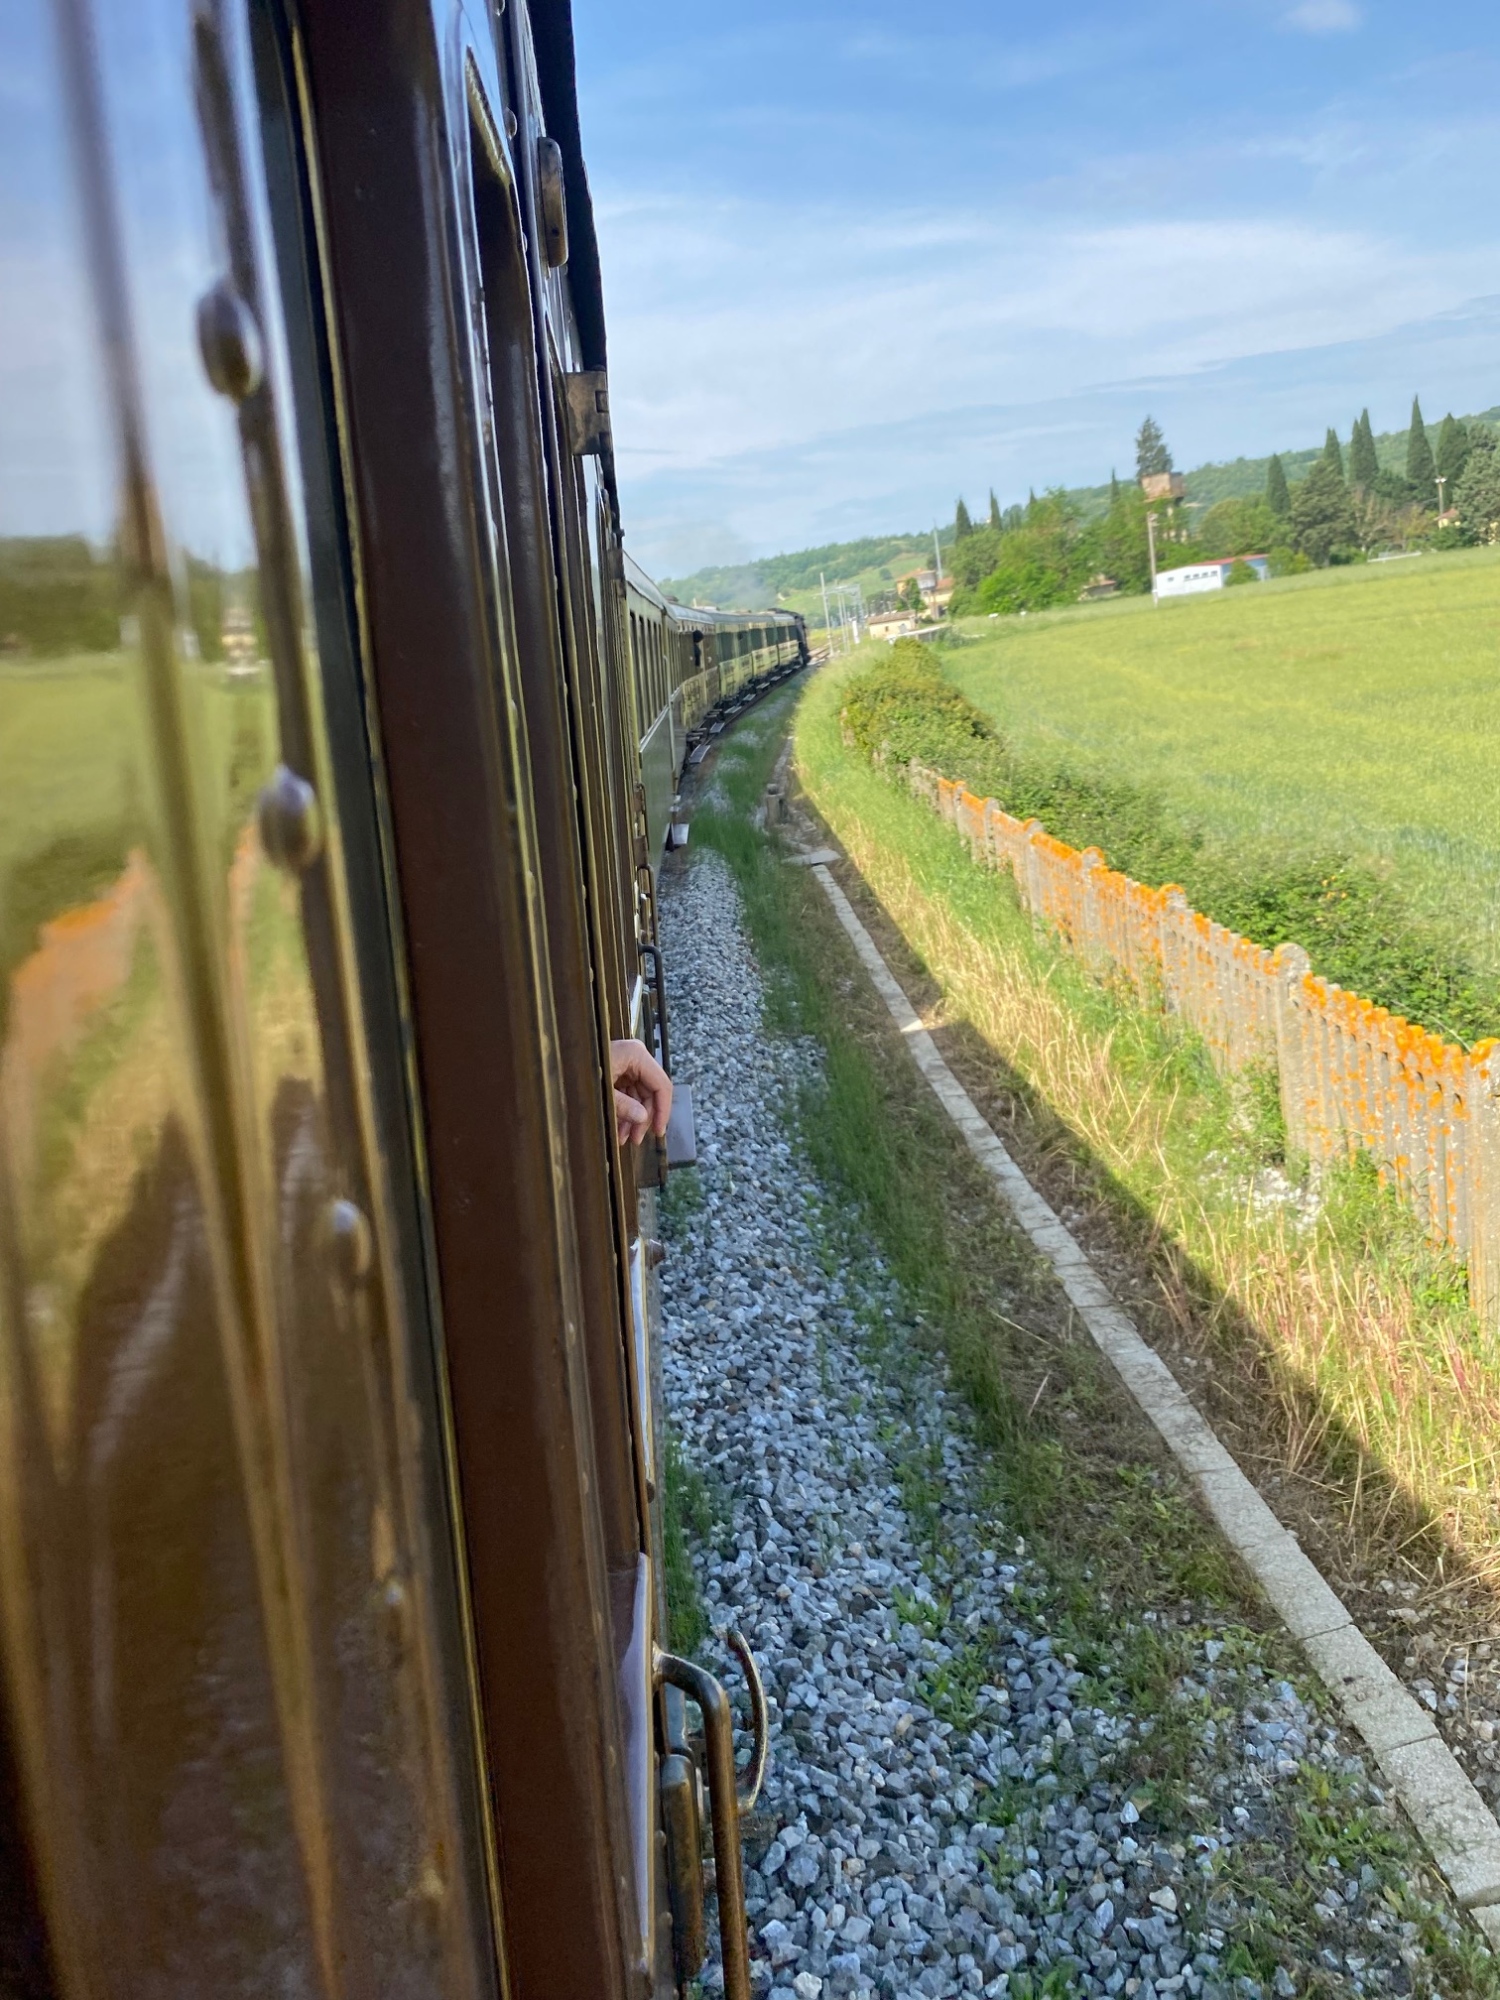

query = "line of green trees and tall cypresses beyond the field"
[950,398,1500,616]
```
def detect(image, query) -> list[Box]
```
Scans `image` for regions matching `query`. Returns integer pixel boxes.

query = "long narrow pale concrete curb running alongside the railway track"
[810,856,1500,1946]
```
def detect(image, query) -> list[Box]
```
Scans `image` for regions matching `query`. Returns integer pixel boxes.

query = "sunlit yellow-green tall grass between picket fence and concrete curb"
[796,648,1500,1580]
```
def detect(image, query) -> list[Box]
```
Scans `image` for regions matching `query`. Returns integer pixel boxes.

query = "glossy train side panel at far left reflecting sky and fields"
[0,0,488,1996]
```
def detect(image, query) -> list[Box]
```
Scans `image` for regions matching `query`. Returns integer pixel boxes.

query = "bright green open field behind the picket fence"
[944,550,1500,968]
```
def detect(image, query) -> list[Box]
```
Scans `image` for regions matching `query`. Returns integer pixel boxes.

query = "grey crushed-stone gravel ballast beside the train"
[662,852,1488,2000]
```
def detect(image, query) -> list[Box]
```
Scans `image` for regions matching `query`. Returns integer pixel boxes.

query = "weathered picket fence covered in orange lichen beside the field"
[906,764,1500,1324]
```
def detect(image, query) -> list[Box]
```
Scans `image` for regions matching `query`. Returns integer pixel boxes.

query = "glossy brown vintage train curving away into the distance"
[0,0,792,2000]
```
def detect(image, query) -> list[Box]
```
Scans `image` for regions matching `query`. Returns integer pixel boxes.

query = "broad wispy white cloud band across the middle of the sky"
[600,196,1496,476]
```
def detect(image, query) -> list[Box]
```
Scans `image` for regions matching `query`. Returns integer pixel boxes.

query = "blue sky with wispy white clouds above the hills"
[574,0,1500,576]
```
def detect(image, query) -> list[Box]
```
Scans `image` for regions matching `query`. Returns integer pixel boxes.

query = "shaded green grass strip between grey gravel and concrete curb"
[692,684,1240,1644]
